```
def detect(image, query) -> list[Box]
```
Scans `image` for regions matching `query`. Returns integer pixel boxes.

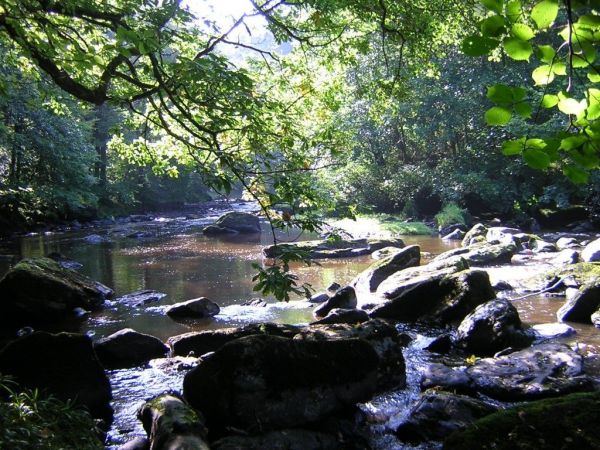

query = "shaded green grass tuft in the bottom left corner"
[0,378,104,450]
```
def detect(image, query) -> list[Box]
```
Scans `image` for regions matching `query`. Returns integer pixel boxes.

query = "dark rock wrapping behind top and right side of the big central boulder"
[294,319,410,390]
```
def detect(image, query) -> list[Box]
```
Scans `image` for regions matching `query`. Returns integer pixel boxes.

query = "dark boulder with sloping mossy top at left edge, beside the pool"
[0,258,113,327]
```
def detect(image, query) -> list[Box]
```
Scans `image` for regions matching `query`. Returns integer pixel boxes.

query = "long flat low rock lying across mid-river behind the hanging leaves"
[263,238,404,259]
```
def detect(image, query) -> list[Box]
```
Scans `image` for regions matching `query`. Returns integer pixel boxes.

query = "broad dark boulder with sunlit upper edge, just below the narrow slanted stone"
[369,270,496,324]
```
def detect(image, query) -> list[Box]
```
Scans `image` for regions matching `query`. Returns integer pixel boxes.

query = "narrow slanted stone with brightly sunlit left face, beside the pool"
[350,245,421,293]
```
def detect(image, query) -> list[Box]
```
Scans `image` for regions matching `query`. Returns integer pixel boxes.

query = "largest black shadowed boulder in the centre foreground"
[183,335,379,435]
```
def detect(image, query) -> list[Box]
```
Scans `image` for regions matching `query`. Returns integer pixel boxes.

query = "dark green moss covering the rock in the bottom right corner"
[444,392,600,450]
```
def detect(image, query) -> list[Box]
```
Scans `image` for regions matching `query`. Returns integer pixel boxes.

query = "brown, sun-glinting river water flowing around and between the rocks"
[0,203,600,449]
